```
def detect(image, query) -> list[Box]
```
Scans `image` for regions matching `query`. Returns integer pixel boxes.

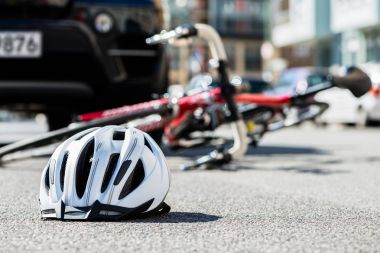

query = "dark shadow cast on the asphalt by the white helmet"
[126,212,222,223]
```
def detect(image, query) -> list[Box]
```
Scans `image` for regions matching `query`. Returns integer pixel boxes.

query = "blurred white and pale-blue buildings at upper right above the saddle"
[271,0,380,67]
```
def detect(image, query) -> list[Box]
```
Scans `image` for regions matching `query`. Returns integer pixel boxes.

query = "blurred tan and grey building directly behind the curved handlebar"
[168,0,269,83]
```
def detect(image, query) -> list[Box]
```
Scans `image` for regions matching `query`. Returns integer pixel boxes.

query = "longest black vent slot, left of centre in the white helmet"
[75,139,95,198]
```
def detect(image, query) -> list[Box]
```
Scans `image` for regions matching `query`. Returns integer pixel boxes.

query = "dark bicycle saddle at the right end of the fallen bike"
[331,67,372,97]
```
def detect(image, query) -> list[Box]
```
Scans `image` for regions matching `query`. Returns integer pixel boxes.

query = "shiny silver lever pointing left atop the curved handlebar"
[145,25,198,45]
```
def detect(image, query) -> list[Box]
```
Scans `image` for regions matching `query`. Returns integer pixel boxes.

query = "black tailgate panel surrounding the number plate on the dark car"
[0,20,126,81]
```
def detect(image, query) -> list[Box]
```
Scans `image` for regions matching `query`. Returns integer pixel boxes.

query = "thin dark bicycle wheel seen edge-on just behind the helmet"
[0,106,170,163]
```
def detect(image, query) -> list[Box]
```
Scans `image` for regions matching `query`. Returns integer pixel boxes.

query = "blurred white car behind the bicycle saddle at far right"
[315,65,380,126]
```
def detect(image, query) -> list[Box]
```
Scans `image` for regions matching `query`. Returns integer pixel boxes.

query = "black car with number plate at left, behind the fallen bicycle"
[0,0,168,129]
